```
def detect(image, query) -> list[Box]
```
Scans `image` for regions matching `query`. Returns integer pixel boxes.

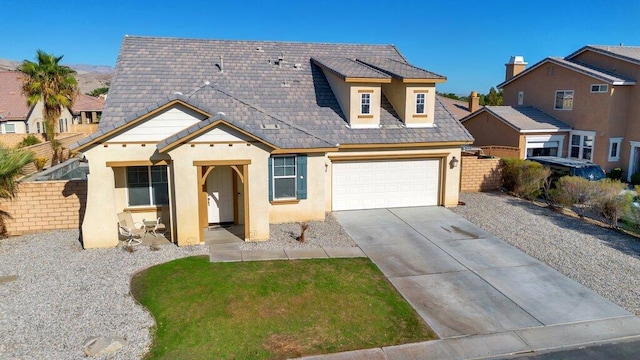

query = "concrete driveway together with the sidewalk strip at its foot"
[334,207,640,359]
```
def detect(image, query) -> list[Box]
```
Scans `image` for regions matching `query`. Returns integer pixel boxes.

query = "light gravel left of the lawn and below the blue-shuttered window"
[0,217,355,360]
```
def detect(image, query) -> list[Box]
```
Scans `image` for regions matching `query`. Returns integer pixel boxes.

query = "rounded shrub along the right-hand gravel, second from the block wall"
[551,176,596,217]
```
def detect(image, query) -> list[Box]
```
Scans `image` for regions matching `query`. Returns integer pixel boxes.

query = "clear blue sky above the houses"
[5,0,640,94]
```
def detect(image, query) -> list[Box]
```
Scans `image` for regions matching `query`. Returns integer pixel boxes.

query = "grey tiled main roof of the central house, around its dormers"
[95,36,472,148]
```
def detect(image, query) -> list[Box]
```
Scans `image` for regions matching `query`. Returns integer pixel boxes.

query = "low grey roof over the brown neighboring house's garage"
[460,106,571,132]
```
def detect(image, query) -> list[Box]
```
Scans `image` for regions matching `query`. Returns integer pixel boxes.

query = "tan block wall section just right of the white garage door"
[460,156,500,192]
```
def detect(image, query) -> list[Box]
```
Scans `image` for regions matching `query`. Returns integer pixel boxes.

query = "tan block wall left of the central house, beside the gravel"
[1,180,87,235]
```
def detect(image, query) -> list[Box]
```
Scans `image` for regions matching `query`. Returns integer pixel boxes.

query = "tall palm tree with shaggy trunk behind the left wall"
[18,50,78,165]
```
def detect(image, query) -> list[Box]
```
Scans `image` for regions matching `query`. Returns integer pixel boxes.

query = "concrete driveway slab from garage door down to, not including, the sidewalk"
[334,207,640,339]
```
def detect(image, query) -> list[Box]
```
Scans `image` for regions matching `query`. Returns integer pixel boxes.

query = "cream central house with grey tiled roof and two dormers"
[72,36,473,248]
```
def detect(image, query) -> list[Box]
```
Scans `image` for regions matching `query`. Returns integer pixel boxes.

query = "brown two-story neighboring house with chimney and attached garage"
[463,45,640,178]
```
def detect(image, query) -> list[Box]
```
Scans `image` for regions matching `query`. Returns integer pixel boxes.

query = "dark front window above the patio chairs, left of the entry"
[127,165,169,206]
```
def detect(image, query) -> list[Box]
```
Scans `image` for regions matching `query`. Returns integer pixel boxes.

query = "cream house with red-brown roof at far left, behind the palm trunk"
[0,71,73,134]
